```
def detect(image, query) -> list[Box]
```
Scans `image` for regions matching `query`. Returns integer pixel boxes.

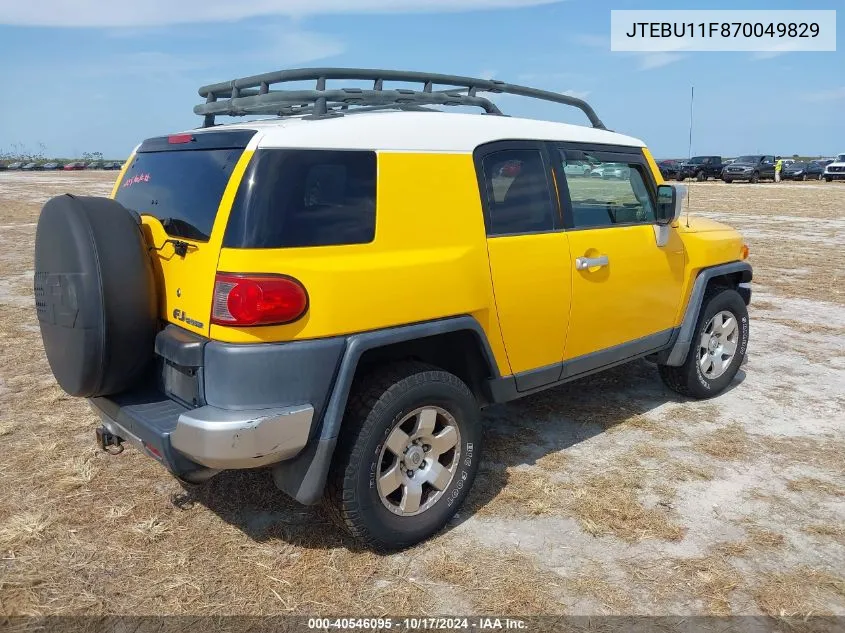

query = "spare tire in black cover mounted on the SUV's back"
[35,195,157,398]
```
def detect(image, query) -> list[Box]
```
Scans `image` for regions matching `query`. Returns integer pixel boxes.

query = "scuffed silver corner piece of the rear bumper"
[170,404,314,469]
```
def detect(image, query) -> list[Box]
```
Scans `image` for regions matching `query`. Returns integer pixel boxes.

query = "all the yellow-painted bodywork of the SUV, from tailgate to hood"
[117,137,742,375]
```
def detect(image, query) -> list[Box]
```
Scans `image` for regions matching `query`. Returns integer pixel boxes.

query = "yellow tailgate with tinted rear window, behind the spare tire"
[113,130,255,336]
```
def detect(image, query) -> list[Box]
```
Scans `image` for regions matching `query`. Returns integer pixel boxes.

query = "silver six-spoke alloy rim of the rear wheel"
[376,406,461,516]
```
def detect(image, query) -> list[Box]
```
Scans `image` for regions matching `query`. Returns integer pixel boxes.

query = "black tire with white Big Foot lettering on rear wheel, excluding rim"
[326,361,481,551]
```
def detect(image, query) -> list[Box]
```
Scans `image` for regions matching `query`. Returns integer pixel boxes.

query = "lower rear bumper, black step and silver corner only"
[89,389,314,477]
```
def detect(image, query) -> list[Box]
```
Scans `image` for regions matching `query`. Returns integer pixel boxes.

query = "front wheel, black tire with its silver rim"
[658,288,748,399]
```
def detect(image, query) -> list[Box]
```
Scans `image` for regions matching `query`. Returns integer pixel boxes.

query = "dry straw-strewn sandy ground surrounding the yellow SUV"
[0,173,845,616]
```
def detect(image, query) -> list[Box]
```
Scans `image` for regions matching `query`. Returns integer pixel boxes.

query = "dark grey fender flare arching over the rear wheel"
[273,315,500,505]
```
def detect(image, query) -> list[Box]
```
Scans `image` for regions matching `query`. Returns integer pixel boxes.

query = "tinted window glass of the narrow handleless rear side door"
[482,149,555,236]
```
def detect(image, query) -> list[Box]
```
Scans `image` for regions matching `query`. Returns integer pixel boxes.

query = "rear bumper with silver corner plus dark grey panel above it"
[90,325,345,477]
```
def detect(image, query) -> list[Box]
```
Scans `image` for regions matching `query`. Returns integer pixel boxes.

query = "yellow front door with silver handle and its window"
[553,144,685,377]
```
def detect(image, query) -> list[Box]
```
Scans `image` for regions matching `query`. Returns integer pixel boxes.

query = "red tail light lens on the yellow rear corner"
[211,273,308,326]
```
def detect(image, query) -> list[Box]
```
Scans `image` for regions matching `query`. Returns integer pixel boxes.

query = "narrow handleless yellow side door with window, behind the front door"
[475,141,571,391]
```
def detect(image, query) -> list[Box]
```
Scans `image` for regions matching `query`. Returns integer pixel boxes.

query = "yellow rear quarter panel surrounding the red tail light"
[210,152,509,374]
